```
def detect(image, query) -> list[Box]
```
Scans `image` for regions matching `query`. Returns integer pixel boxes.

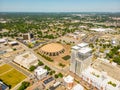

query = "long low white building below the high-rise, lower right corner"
[82,67,120,90]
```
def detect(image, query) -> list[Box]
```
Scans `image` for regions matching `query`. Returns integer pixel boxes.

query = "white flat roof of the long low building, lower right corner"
[82,67,120,90]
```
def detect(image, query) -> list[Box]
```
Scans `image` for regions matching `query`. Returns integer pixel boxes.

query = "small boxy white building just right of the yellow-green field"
[34,67,47,80]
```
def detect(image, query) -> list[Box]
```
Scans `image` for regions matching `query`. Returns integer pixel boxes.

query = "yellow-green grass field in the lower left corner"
[0,65,26,88]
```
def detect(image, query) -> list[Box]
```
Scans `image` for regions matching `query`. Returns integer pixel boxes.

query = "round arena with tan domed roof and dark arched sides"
[40,43,65,56]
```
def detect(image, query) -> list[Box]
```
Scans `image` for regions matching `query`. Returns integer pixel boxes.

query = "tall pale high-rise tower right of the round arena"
[70,43,92,76]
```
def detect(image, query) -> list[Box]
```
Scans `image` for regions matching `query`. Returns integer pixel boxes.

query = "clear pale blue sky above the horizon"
[0,0,120,12]
